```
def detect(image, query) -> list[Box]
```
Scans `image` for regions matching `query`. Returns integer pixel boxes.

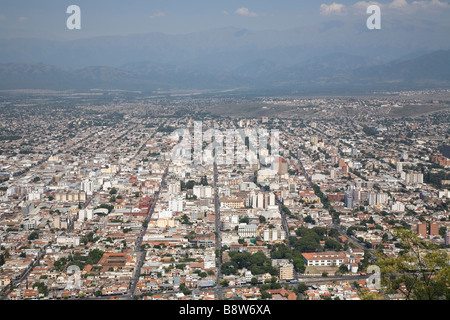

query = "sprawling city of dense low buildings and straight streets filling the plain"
[0,90,450,300]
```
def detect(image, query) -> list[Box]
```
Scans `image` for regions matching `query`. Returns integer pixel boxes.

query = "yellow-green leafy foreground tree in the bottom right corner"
[377,229,450,300]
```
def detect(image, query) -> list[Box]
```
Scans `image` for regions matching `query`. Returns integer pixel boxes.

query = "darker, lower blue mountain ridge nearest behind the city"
[0,49,450,92]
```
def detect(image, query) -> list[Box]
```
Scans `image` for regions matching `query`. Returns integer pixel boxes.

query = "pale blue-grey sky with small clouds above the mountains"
[0,0,450,40]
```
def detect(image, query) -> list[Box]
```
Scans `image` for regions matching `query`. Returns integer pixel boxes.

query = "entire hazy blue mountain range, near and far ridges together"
[0,28,450,93]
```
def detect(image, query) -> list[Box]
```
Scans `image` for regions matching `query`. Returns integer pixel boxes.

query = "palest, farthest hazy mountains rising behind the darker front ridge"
[0,27,412,70]
